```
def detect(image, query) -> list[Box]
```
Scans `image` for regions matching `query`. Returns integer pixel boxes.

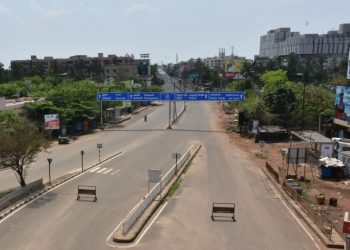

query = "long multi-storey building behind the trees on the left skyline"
[11,53,151,80]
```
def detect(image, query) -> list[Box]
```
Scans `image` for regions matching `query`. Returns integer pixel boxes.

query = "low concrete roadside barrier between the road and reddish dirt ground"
[261,167,344,249]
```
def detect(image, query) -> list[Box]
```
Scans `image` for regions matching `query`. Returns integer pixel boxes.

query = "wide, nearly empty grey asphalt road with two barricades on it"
[0,100,317,250]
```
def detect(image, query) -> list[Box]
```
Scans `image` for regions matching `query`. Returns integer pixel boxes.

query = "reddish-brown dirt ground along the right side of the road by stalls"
[220,104,350,235]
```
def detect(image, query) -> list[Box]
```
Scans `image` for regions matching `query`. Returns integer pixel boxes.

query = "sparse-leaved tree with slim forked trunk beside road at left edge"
[0,111,48,187]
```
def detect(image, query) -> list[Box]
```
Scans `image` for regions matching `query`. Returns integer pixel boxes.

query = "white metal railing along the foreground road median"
[123,145,194,234]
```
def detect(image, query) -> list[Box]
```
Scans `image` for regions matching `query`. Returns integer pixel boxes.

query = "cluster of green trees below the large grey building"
[239,69,334,131]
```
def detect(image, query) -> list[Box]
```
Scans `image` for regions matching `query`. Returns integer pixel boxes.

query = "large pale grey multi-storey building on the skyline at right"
[259,23,350,64]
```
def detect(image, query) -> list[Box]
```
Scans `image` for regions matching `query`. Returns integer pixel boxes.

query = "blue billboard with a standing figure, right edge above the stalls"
[333,86,350,128]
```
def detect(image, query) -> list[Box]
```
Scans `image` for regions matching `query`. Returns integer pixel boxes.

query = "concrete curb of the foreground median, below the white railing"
[113,145,202,243]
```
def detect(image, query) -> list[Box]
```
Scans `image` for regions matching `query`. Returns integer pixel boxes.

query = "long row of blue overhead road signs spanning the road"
[97,92,244,101]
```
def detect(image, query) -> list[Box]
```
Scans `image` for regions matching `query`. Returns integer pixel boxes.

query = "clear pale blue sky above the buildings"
[0,0,350,68]
